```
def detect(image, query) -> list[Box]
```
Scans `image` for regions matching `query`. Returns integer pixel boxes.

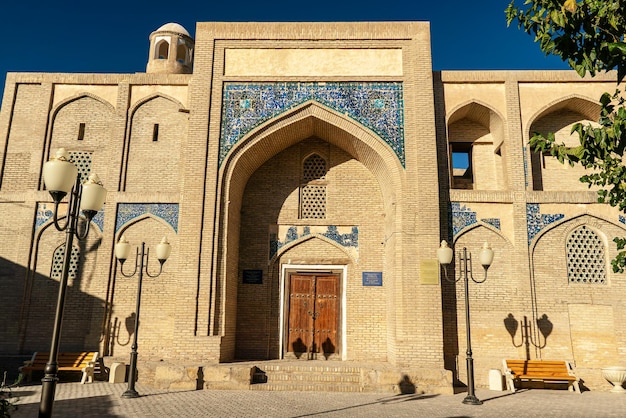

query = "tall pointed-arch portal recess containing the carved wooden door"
[216,102,402,361]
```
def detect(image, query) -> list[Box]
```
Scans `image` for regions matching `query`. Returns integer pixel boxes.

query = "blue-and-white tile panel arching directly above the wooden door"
[269,225,359,260]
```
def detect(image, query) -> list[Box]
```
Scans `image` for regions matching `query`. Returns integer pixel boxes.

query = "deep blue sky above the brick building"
[0,0,568,99]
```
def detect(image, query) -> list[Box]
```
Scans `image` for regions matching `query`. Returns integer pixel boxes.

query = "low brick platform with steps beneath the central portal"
[105,357,453,394]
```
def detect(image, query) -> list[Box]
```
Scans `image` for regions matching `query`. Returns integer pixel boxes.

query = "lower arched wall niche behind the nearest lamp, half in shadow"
[19,217,106,352]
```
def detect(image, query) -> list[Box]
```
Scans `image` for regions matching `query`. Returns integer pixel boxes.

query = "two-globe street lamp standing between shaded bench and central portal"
[115,235,172,398]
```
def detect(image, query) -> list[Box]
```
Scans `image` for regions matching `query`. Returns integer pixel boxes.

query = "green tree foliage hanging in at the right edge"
[505,0,626,272]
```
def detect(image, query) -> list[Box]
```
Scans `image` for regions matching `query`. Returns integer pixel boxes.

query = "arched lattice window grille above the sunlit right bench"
[566,225,606,284]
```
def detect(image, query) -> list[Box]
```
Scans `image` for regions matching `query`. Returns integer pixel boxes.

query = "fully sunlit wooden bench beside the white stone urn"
[502,360,580,393]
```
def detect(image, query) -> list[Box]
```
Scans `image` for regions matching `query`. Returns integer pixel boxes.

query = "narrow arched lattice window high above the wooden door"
[300,154,326,219]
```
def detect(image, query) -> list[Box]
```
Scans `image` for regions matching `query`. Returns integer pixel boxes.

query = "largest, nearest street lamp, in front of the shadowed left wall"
[39,148,107,417]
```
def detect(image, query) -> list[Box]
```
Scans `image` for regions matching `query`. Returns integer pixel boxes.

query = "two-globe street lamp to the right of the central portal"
[437,240,493,405]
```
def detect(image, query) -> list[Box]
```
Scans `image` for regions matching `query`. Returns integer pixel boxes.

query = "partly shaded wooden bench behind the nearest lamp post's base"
[19,351,98,383]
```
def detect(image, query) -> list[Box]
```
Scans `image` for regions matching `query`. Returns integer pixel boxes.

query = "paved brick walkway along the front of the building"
[4,382,626,418]
